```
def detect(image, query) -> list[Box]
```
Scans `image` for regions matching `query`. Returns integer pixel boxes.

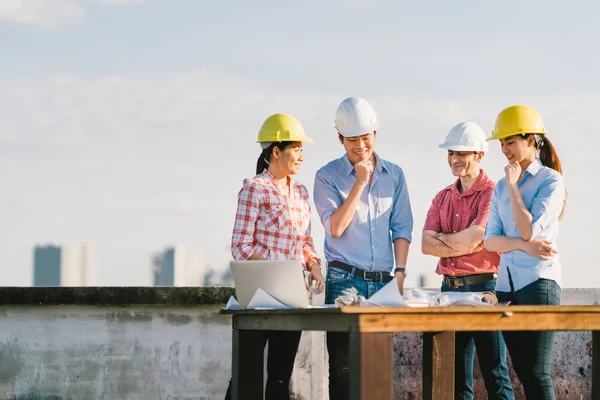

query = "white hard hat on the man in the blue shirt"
[335,97,379,137]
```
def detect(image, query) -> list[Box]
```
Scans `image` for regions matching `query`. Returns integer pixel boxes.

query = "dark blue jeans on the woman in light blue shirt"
[498,273,560,400]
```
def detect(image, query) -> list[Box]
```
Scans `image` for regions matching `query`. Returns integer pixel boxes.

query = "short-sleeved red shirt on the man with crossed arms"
[423,170,500,276]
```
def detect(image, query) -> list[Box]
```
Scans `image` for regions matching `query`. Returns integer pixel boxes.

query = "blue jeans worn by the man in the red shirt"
[442,279,515,400]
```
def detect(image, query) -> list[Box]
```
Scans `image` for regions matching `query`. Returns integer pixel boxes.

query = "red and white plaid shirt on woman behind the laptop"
[231,170,320,268]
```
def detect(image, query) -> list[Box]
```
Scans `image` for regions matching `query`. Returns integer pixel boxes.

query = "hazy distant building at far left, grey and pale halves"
[33,245,94,286]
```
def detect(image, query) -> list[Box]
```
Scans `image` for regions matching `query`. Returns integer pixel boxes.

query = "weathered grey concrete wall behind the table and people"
[0,288,600,400]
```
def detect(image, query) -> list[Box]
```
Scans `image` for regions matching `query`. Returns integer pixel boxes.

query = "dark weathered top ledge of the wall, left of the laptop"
[0,286,235,306]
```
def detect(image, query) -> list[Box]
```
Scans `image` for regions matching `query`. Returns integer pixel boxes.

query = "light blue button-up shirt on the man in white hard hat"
[314,153,413,272]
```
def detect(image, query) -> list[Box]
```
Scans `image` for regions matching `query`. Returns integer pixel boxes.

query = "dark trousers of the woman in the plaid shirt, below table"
[225,331,302,400]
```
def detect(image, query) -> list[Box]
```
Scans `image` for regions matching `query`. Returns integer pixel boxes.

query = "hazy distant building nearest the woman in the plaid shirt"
[152,244,205,286]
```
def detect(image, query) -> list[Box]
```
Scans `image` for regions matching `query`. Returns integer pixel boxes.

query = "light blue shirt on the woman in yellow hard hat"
[484,158,565,292]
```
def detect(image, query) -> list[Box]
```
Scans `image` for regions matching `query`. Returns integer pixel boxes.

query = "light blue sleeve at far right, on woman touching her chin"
[530,174,565,238]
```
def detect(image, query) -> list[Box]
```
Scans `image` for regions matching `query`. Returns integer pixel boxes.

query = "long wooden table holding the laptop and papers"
[223,306,600,400]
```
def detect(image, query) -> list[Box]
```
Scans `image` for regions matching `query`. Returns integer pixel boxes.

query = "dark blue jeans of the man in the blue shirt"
[325,267,386,400]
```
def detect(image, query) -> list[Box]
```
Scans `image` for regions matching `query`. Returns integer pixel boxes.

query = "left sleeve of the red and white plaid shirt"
[231,179,260,260]
